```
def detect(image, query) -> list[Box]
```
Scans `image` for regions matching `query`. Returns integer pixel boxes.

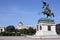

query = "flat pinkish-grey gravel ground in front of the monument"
[0,36,60,40]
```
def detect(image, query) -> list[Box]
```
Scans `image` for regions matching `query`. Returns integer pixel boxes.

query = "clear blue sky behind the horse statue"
[0,0,60,26]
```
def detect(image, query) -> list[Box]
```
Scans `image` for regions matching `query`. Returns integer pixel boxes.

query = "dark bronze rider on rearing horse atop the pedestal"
[42,2,54,18]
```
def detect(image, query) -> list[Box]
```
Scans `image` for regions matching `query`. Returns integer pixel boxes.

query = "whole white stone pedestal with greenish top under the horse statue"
[35,18,57,36]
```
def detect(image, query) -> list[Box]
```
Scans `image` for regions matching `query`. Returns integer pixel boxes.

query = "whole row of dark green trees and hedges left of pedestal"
[0,25,36,36]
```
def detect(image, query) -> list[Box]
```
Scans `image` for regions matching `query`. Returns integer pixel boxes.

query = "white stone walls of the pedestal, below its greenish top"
[36,24,57,36]
